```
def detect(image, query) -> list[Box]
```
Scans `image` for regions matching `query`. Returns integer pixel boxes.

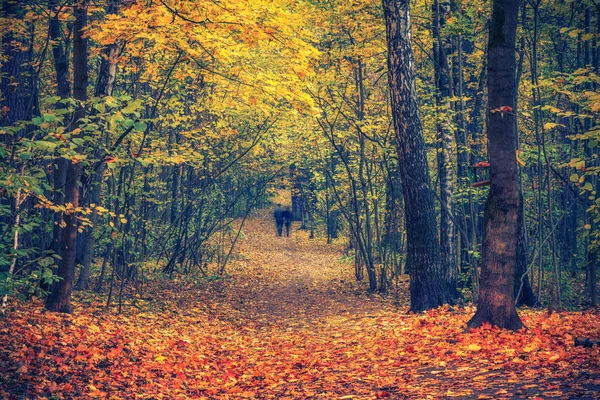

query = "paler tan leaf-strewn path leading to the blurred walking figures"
[221,209,392,327]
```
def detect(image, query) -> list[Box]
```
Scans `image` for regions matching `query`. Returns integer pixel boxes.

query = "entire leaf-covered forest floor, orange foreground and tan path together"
[0,210,600,399]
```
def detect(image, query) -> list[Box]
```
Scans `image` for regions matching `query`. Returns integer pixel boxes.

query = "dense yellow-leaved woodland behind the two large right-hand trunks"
[0,0,600,311]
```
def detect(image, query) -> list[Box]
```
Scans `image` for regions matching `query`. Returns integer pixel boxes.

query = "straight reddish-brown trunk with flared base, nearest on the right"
[468,0,523,330]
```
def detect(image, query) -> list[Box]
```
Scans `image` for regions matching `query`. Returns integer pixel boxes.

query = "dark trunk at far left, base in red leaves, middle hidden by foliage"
[46,0,88,313]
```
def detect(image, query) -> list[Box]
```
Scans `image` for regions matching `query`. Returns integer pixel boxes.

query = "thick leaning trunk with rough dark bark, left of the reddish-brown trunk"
[383,0,455,311]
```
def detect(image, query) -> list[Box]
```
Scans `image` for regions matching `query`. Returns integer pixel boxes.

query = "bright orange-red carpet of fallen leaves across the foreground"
[0,292,600,399]
